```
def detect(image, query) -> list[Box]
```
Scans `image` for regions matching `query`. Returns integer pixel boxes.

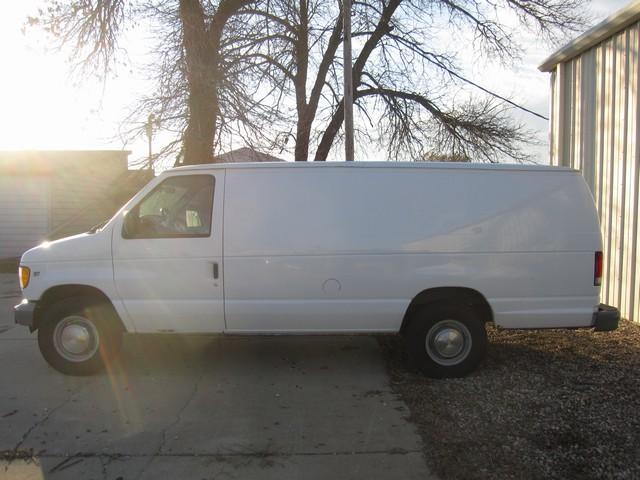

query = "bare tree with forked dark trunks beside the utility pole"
[234,0,584,161]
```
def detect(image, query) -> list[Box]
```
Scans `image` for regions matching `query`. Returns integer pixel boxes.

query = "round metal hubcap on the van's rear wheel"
[425,320,471,366]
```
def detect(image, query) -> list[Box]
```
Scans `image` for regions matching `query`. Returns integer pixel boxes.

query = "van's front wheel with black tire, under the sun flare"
[38,297,123,375]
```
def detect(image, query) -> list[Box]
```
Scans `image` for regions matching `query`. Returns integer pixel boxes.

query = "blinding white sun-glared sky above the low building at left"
[0,0,146,158]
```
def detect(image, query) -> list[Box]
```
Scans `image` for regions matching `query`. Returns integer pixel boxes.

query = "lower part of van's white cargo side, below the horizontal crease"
[225,253,598,333]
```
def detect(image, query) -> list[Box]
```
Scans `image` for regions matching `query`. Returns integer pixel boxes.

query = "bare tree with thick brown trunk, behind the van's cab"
[29,0,258,164]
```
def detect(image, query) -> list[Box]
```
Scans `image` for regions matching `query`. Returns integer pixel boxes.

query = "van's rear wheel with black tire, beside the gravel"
[405,302,487,378]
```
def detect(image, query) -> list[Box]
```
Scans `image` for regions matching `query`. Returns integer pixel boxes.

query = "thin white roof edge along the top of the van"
[167,162,578,172]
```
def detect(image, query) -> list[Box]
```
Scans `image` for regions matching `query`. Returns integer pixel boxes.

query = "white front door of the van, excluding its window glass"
[112,170,225,333]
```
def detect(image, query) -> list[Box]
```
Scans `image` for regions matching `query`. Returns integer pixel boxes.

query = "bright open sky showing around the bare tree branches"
[0,0,629,171]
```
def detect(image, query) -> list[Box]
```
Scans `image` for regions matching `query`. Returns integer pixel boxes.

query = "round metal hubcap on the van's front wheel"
[53,315,99,362]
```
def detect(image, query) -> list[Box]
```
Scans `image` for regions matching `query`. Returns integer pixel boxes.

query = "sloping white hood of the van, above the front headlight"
[20,230,111,266]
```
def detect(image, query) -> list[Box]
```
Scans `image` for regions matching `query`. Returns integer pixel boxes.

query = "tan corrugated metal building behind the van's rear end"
[539,2,640,321]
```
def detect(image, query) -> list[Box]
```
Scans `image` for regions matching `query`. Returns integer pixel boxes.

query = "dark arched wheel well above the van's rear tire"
[400,287,493,335]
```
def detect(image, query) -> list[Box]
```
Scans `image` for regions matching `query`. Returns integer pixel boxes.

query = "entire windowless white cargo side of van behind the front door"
[224,167,600,333]
